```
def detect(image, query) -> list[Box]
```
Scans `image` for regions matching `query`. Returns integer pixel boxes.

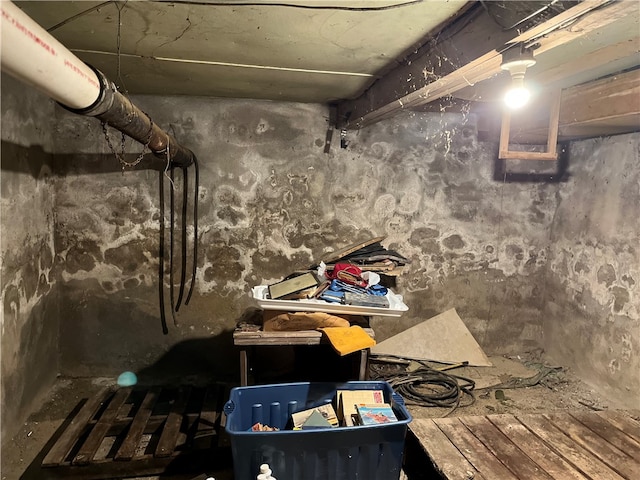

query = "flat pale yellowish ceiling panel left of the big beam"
[15,0,467,103]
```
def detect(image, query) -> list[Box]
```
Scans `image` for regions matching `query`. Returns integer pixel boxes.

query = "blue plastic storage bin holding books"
[224,381,411,480]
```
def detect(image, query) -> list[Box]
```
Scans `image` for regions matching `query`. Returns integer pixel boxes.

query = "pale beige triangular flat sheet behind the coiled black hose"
[371,308,492,367]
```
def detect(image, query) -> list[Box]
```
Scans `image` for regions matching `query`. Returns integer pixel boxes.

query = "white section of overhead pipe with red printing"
[0,0,100,109]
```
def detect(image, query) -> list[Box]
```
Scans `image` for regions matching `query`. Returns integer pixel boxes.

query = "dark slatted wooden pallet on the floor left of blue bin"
[42,385,231,479]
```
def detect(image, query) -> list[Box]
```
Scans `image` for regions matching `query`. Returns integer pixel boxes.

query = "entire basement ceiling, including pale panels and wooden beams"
[10,0,640,138]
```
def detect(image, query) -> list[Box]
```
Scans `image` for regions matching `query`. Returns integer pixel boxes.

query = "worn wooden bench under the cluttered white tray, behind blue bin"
[233,328,375,386]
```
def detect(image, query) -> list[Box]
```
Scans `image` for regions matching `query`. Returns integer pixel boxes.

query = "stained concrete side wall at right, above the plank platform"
[544,133,640,408]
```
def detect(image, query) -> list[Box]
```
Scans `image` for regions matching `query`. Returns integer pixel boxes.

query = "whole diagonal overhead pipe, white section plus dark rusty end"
[0,1,195,167]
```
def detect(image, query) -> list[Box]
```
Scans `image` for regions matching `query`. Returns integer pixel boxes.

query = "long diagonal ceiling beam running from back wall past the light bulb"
[337,0,637,129]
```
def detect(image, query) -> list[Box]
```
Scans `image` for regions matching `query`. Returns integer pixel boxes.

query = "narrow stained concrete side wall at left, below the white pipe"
[0,75,59,441]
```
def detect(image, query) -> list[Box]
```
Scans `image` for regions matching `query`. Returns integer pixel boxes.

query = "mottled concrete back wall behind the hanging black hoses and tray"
[54,96,557,379]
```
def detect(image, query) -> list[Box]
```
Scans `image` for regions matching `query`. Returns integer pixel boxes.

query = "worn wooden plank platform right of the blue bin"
[409,411,640,480]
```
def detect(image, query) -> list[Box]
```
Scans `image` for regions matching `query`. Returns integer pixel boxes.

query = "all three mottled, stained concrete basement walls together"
[2,78,639,433]
